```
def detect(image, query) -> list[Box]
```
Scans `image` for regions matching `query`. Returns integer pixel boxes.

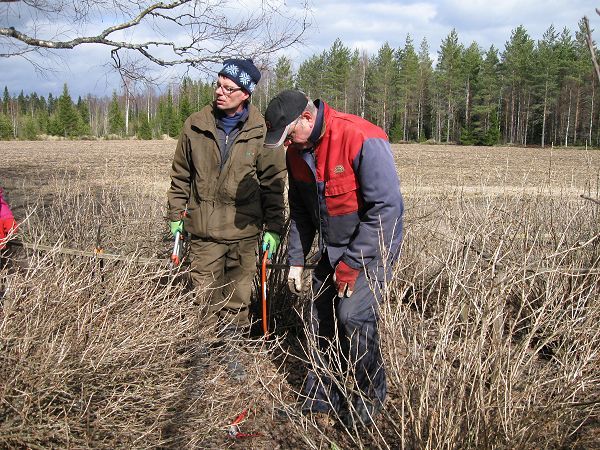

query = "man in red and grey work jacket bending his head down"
[265,90,404,426]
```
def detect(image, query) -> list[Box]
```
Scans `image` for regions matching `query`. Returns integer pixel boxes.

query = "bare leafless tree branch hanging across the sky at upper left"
[0,0,310,78]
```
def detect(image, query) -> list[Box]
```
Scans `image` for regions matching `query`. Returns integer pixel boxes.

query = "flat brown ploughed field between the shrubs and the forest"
[0,140,600,196]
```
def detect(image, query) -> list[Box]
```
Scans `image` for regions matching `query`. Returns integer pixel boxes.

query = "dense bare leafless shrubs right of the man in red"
[262,188,600,448]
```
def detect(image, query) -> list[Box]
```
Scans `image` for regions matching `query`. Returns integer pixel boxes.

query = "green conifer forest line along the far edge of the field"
[0,21,600,147]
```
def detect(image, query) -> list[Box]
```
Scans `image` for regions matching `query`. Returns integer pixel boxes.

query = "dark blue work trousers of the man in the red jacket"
[303,255,387,414]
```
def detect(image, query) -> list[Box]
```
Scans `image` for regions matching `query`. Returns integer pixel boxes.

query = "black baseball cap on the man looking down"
[265,89,308,147]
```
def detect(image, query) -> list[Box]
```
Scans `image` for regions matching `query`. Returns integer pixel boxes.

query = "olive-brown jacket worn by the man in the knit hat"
[167,105,286,242]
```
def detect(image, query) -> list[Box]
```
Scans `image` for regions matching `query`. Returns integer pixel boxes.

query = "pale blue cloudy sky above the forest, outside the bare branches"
[0,0,600,98]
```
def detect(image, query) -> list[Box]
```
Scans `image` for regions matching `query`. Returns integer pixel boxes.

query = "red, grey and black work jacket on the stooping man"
[287,100,404,269]
